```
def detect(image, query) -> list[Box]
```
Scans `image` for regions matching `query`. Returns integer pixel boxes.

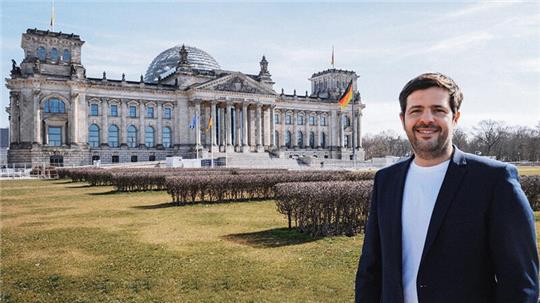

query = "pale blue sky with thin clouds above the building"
[0,0,540,134]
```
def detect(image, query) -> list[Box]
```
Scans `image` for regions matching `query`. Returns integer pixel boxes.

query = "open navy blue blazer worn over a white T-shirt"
[355,147,538,303]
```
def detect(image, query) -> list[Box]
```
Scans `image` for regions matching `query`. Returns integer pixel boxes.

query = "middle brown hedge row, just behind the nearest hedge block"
[165,171,374,204]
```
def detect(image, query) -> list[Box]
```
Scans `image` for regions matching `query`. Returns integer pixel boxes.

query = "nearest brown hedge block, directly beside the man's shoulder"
[275,181,373,237]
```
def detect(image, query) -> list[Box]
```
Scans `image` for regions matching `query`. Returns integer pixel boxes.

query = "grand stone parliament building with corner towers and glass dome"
[6,29,364,165]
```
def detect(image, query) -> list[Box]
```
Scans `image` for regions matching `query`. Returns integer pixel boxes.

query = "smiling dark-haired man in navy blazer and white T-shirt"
[356,73,538,303]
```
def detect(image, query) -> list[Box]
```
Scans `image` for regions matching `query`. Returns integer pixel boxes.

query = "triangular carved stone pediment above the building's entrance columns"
[194,73,275,95]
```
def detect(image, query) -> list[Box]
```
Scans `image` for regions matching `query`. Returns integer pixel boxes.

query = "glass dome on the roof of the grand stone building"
[144,45,221,82]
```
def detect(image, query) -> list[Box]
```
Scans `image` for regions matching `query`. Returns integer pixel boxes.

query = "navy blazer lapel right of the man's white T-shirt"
[420,146,467,267]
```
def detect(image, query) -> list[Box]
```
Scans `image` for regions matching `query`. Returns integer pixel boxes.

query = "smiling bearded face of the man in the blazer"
[400,87,459,160]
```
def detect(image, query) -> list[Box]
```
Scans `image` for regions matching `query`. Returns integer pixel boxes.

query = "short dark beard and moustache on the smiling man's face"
[406,124,452,160]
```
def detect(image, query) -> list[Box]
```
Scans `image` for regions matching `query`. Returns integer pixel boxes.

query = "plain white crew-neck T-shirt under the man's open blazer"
[401,160,450,303]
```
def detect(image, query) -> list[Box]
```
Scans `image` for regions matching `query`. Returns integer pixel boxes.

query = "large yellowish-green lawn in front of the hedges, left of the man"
[0,180,362,303]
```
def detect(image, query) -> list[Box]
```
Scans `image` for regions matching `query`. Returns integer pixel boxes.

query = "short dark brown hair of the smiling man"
[399,73,463,114]
